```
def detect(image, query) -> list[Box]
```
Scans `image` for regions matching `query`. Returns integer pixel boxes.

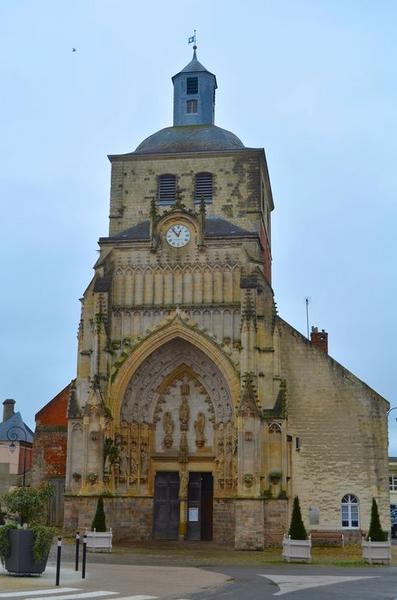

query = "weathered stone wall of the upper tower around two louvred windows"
[109,150,270,235]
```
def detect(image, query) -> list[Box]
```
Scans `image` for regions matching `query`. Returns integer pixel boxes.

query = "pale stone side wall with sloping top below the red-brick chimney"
[277,319,390,530]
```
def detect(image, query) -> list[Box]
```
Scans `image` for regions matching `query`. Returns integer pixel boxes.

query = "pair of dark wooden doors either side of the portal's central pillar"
[153,471,213,540]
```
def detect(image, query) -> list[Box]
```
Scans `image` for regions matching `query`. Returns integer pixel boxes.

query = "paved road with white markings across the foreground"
[0,555,397,600]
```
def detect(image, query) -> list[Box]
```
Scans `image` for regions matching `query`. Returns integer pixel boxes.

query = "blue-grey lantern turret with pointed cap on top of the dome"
[172,46,217,126]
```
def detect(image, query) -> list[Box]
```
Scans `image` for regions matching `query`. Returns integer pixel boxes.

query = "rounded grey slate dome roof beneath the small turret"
[135,125,244,154]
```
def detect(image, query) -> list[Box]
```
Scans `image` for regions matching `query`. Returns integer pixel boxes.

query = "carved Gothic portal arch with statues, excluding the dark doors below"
[109,337,236,539]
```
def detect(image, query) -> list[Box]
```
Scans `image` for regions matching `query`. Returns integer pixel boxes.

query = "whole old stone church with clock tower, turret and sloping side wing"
[65,49,390,549]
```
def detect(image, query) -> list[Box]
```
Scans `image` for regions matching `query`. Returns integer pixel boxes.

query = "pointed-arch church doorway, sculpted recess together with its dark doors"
[120,338,235,540]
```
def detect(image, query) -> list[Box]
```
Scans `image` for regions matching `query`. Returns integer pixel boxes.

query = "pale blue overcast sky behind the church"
[0,0,397,455]
